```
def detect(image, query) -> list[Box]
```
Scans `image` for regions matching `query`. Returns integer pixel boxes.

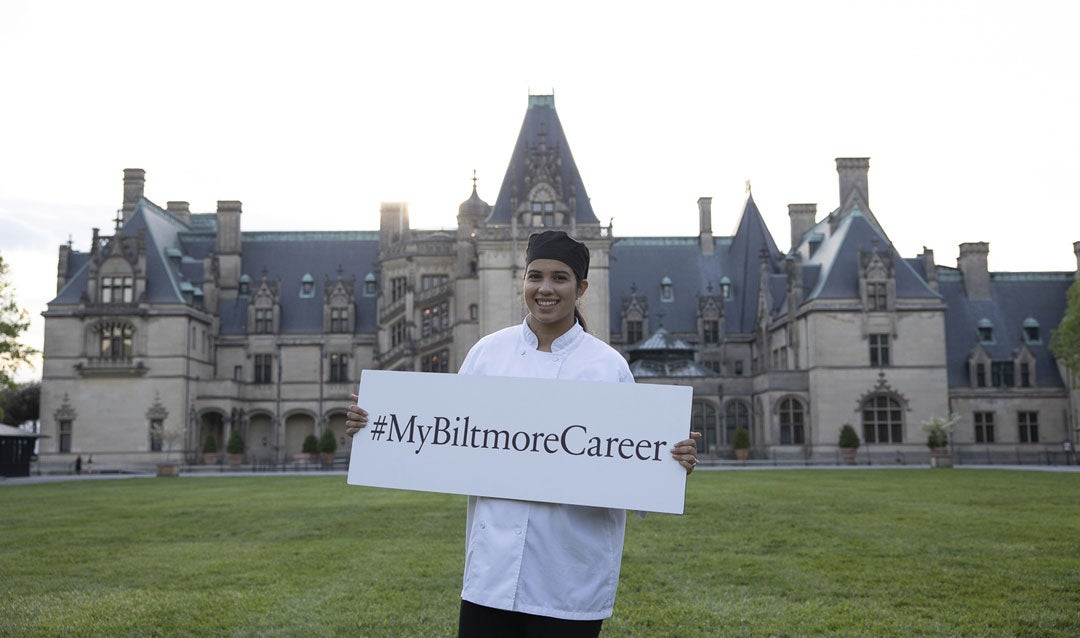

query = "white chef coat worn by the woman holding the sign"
[459,322,634,621]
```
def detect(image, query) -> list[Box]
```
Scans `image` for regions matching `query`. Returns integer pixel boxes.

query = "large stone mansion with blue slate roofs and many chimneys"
[40,95,1080,471]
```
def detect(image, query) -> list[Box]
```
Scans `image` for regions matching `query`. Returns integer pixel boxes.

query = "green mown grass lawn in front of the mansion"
[0,470,1080,637]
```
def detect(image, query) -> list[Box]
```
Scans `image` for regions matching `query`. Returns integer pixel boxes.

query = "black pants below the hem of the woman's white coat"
[458,600,604,638]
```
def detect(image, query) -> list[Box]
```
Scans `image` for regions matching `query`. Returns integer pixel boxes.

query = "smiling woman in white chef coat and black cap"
[346,230,701,638]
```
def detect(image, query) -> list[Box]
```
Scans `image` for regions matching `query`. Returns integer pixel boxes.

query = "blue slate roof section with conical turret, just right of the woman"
[610,198,780,334]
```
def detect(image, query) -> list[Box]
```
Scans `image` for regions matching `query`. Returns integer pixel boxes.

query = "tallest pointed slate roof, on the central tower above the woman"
[487,95,599,223]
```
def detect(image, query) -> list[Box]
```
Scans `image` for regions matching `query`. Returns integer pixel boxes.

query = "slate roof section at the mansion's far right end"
[937,267,1075,388]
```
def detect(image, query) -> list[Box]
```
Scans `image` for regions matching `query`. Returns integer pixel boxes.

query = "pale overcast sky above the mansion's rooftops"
[0,0,1080,378]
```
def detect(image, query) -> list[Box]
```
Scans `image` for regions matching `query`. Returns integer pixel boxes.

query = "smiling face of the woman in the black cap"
[523,259,589,337]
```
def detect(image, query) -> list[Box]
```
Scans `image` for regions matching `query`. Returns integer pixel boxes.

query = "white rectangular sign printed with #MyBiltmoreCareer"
[349,370,693,514]
